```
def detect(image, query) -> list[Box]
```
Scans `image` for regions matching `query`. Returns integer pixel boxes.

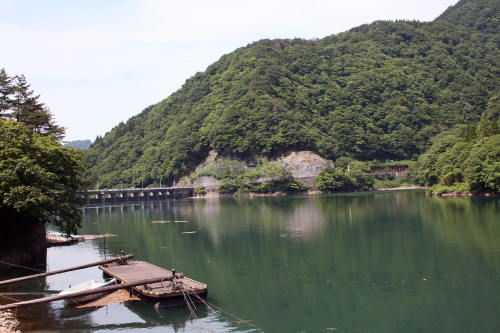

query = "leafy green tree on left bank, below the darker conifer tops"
[0,119,86,249]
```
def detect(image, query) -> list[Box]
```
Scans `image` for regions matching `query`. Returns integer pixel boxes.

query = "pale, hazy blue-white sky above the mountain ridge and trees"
[0,0,458,141]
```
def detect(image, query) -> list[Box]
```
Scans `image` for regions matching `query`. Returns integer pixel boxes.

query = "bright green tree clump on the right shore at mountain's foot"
[419,94,500,194]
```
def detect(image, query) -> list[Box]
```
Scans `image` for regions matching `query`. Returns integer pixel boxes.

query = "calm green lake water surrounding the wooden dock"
[0,191,500,332]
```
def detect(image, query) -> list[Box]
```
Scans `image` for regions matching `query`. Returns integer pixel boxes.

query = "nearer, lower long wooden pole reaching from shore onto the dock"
[0,275,173,311]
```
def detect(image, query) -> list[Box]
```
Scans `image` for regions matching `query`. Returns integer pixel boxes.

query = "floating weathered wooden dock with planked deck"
[99,261,208,308]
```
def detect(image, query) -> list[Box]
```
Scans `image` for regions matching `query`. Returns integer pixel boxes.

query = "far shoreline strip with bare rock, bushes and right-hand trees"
[185,146,500,197]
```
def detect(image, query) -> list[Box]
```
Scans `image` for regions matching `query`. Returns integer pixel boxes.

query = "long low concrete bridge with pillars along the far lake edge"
[85,187,194,205]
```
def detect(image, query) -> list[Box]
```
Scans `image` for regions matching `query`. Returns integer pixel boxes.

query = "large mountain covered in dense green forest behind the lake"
[87,0,500,187]
